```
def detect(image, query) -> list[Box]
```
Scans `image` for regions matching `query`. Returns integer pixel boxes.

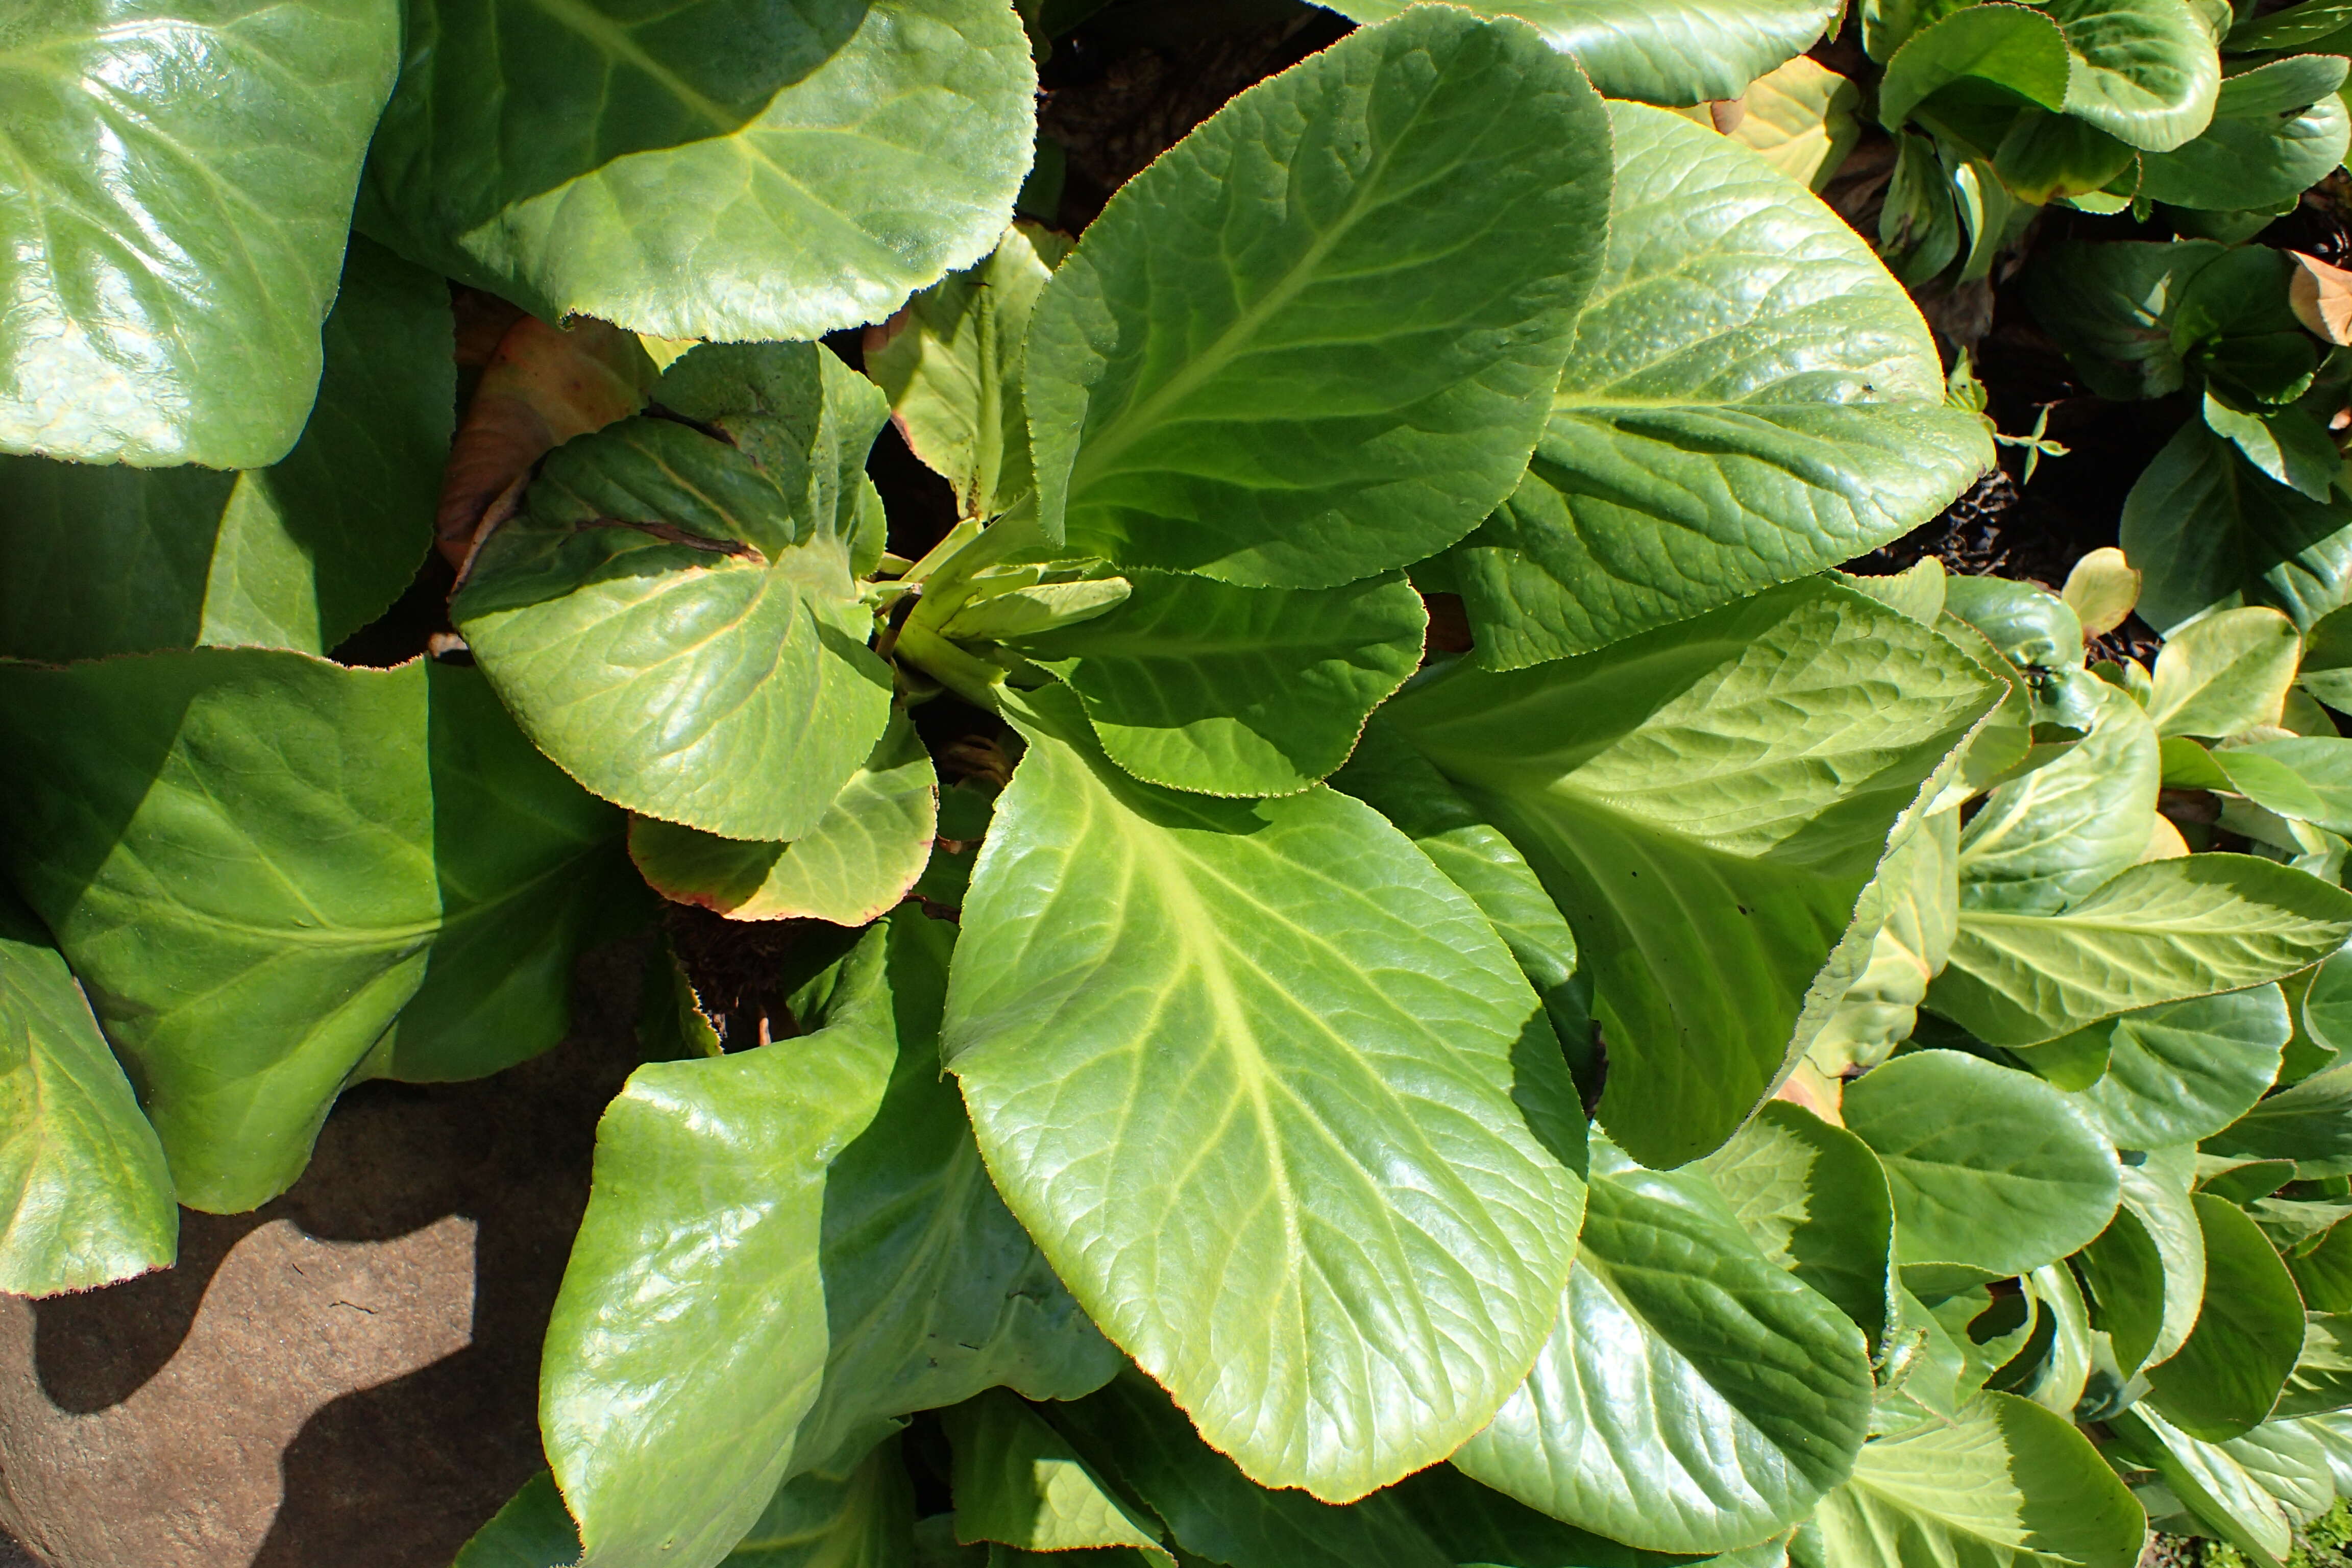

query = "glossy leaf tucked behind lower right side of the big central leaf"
[1454,1147,1872,1552]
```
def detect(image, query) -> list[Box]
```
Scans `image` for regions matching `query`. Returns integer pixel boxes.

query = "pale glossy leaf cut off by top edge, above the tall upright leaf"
[1324,0,1839,104]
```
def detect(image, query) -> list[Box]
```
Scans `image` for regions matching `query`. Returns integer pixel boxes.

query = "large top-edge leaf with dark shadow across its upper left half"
[360,0,1037,341]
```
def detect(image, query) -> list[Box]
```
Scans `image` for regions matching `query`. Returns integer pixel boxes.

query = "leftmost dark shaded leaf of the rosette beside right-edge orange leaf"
[2025,240,2225,402]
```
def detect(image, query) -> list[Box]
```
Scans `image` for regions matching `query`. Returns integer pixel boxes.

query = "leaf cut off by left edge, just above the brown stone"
[0,886,179,1295]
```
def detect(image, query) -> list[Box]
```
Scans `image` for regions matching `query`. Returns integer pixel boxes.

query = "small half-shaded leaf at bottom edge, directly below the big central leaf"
[943,1389,1173,1563]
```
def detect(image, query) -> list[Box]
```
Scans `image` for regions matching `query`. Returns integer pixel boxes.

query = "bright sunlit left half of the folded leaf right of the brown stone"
[538,931,903,1568]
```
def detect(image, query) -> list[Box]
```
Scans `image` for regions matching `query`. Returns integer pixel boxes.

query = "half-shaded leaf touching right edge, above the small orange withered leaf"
[2138,54,2352,209]
